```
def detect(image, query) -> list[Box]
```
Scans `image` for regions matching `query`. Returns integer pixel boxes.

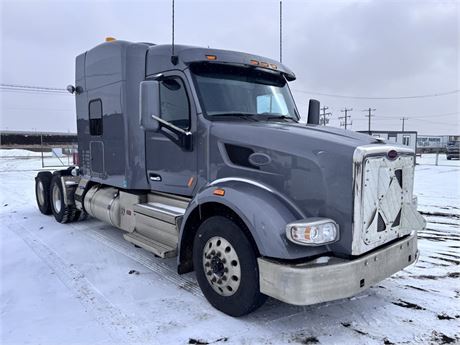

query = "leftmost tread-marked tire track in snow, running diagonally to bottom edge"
[8,224,146,343]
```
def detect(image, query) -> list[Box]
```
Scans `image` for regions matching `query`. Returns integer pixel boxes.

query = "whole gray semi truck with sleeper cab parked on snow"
[36,40,425,316]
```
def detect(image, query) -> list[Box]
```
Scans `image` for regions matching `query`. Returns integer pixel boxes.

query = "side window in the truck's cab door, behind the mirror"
[160,78,190,129]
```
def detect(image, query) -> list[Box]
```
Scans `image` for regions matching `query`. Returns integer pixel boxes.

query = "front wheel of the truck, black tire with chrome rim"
[193,216,267,316]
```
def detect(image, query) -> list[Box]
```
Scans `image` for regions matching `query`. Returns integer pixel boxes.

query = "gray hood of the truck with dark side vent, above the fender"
[208,120,385,254]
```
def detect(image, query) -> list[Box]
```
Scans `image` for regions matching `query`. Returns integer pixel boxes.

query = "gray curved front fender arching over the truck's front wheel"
[178,177,328,271]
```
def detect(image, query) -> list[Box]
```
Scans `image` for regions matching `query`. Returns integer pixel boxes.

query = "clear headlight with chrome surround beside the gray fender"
[286,218,339,246]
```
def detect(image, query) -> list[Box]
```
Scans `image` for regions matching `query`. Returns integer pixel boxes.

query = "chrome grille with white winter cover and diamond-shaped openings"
[352,145,424,255]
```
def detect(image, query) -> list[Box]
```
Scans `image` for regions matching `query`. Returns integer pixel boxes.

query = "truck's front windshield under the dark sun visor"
[192,64,298,121]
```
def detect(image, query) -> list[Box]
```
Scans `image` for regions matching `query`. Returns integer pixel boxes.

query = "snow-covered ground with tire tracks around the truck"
[0,151,460,345]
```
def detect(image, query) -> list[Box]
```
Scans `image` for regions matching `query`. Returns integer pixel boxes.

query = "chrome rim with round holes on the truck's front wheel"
[203,236,241,296]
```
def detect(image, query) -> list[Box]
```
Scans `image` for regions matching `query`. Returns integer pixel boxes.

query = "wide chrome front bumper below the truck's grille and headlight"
[257,232,418,305]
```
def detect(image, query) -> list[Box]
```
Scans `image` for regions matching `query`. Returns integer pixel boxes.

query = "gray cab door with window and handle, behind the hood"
[145,71,197,196]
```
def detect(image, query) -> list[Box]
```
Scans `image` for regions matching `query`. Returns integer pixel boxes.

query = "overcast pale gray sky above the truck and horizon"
[0,0,460,134]
